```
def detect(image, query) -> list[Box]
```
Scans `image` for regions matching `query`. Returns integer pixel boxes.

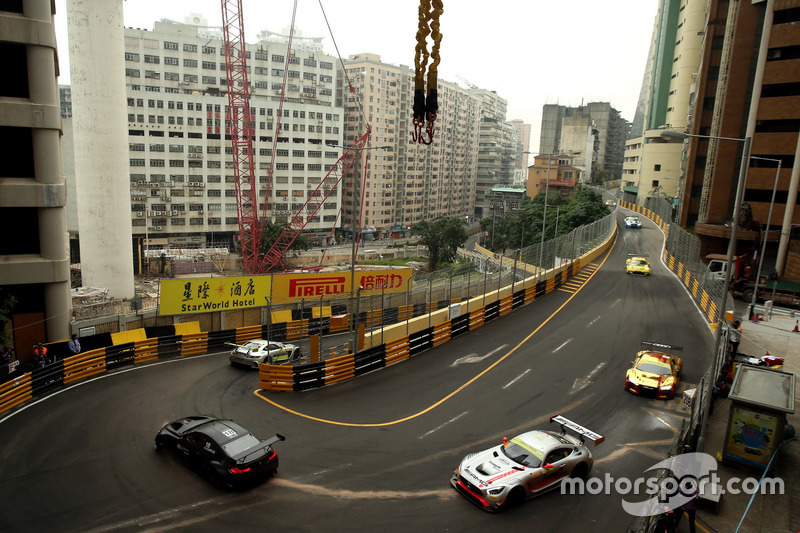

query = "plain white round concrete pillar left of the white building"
[67,0,134,298]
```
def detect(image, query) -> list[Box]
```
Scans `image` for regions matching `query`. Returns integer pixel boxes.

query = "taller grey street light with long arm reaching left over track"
[661,130,752,451]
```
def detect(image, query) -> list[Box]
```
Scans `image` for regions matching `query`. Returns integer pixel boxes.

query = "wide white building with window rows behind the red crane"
[62,20,344,254]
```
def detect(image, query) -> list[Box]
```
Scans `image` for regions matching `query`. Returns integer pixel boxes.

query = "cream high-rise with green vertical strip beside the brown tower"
[621,0,708,202]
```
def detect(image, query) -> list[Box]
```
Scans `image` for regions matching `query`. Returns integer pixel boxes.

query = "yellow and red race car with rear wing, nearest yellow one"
[625,341,683,399]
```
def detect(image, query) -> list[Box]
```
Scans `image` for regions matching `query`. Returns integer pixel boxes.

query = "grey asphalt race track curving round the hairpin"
[0,210,713,532]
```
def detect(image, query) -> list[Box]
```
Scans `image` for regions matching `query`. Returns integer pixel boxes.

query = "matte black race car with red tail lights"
[155,416,286,488]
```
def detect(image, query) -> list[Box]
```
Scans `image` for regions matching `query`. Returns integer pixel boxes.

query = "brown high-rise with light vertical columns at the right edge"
[679,0,800,274]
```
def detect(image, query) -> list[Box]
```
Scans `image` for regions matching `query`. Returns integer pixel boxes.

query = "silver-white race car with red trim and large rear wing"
[450,415,605,512]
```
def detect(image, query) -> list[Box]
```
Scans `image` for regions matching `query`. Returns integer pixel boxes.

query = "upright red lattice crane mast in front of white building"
[221,0,260,274]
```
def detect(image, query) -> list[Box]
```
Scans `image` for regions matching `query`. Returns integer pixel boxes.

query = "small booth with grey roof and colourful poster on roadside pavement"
[722,364,794,471]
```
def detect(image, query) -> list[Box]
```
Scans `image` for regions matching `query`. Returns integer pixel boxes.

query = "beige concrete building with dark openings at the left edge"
[0,0,71,350]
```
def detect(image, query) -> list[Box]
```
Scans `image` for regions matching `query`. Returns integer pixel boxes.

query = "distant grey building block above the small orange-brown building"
[539,102,630,183]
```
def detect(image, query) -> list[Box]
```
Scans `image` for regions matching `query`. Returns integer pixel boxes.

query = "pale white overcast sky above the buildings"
[56,0,657,151]
